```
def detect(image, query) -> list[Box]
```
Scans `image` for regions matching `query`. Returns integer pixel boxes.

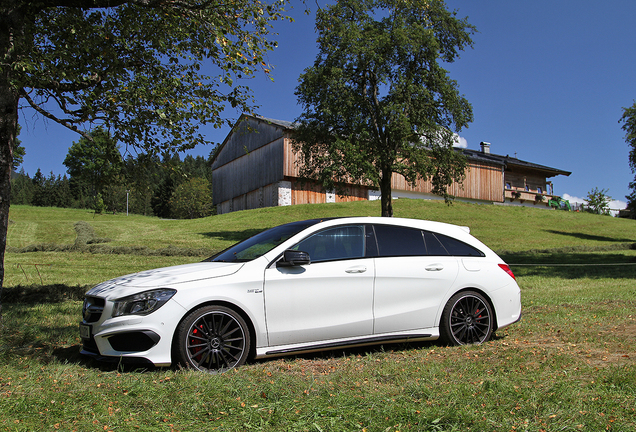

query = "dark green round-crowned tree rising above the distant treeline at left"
[63,127,124,194]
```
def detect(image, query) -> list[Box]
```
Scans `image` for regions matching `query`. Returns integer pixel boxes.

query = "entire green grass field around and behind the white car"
[0,200,636,431]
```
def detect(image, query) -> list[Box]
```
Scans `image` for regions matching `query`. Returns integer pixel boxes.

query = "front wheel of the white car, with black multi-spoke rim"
[175,306,250,373]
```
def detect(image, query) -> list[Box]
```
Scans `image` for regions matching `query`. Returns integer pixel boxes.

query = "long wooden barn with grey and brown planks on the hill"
[212,114,571,214]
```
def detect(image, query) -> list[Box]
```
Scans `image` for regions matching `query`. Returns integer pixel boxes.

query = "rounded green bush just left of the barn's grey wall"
[170,178,214,219]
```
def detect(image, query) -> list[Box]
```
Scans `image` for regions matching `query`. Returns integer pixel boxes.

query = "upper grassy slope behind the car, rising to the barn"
[8,199,636,251]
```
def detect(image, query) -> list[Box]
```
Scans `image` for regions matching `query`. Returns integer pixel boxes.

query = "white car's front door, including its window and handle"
[264,225,375,346]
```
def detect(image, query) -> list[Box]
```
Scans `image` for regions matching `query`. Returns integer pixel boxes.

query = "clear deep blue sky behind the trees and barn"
[20,0,636,209]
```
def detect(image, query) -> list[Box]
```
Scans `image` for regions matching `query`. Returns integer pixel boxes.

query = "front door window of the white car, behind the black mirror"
[292,225,365,262]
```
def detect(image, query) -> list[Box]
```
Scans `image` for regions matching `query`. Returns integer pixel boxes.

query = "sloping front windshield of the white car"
[205,219,322,262]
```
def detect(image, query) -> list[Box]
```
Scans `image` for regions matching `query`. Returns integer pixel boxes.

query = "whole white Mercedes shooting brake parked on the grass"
[80,217,521,372]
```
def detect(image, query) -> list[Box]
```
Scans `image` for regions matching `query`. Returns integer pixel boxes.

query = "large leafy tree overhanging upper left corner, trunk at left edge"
[0,0,285,317]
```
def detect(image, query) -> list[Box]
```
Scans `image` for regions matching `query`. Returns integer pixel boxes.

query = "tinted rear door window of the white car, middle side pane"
[374,225,426,257]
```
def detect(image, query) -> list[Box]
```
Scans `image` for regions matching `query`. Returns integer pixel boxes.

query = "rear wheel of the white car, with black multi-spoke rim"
[439,291,494,345]
